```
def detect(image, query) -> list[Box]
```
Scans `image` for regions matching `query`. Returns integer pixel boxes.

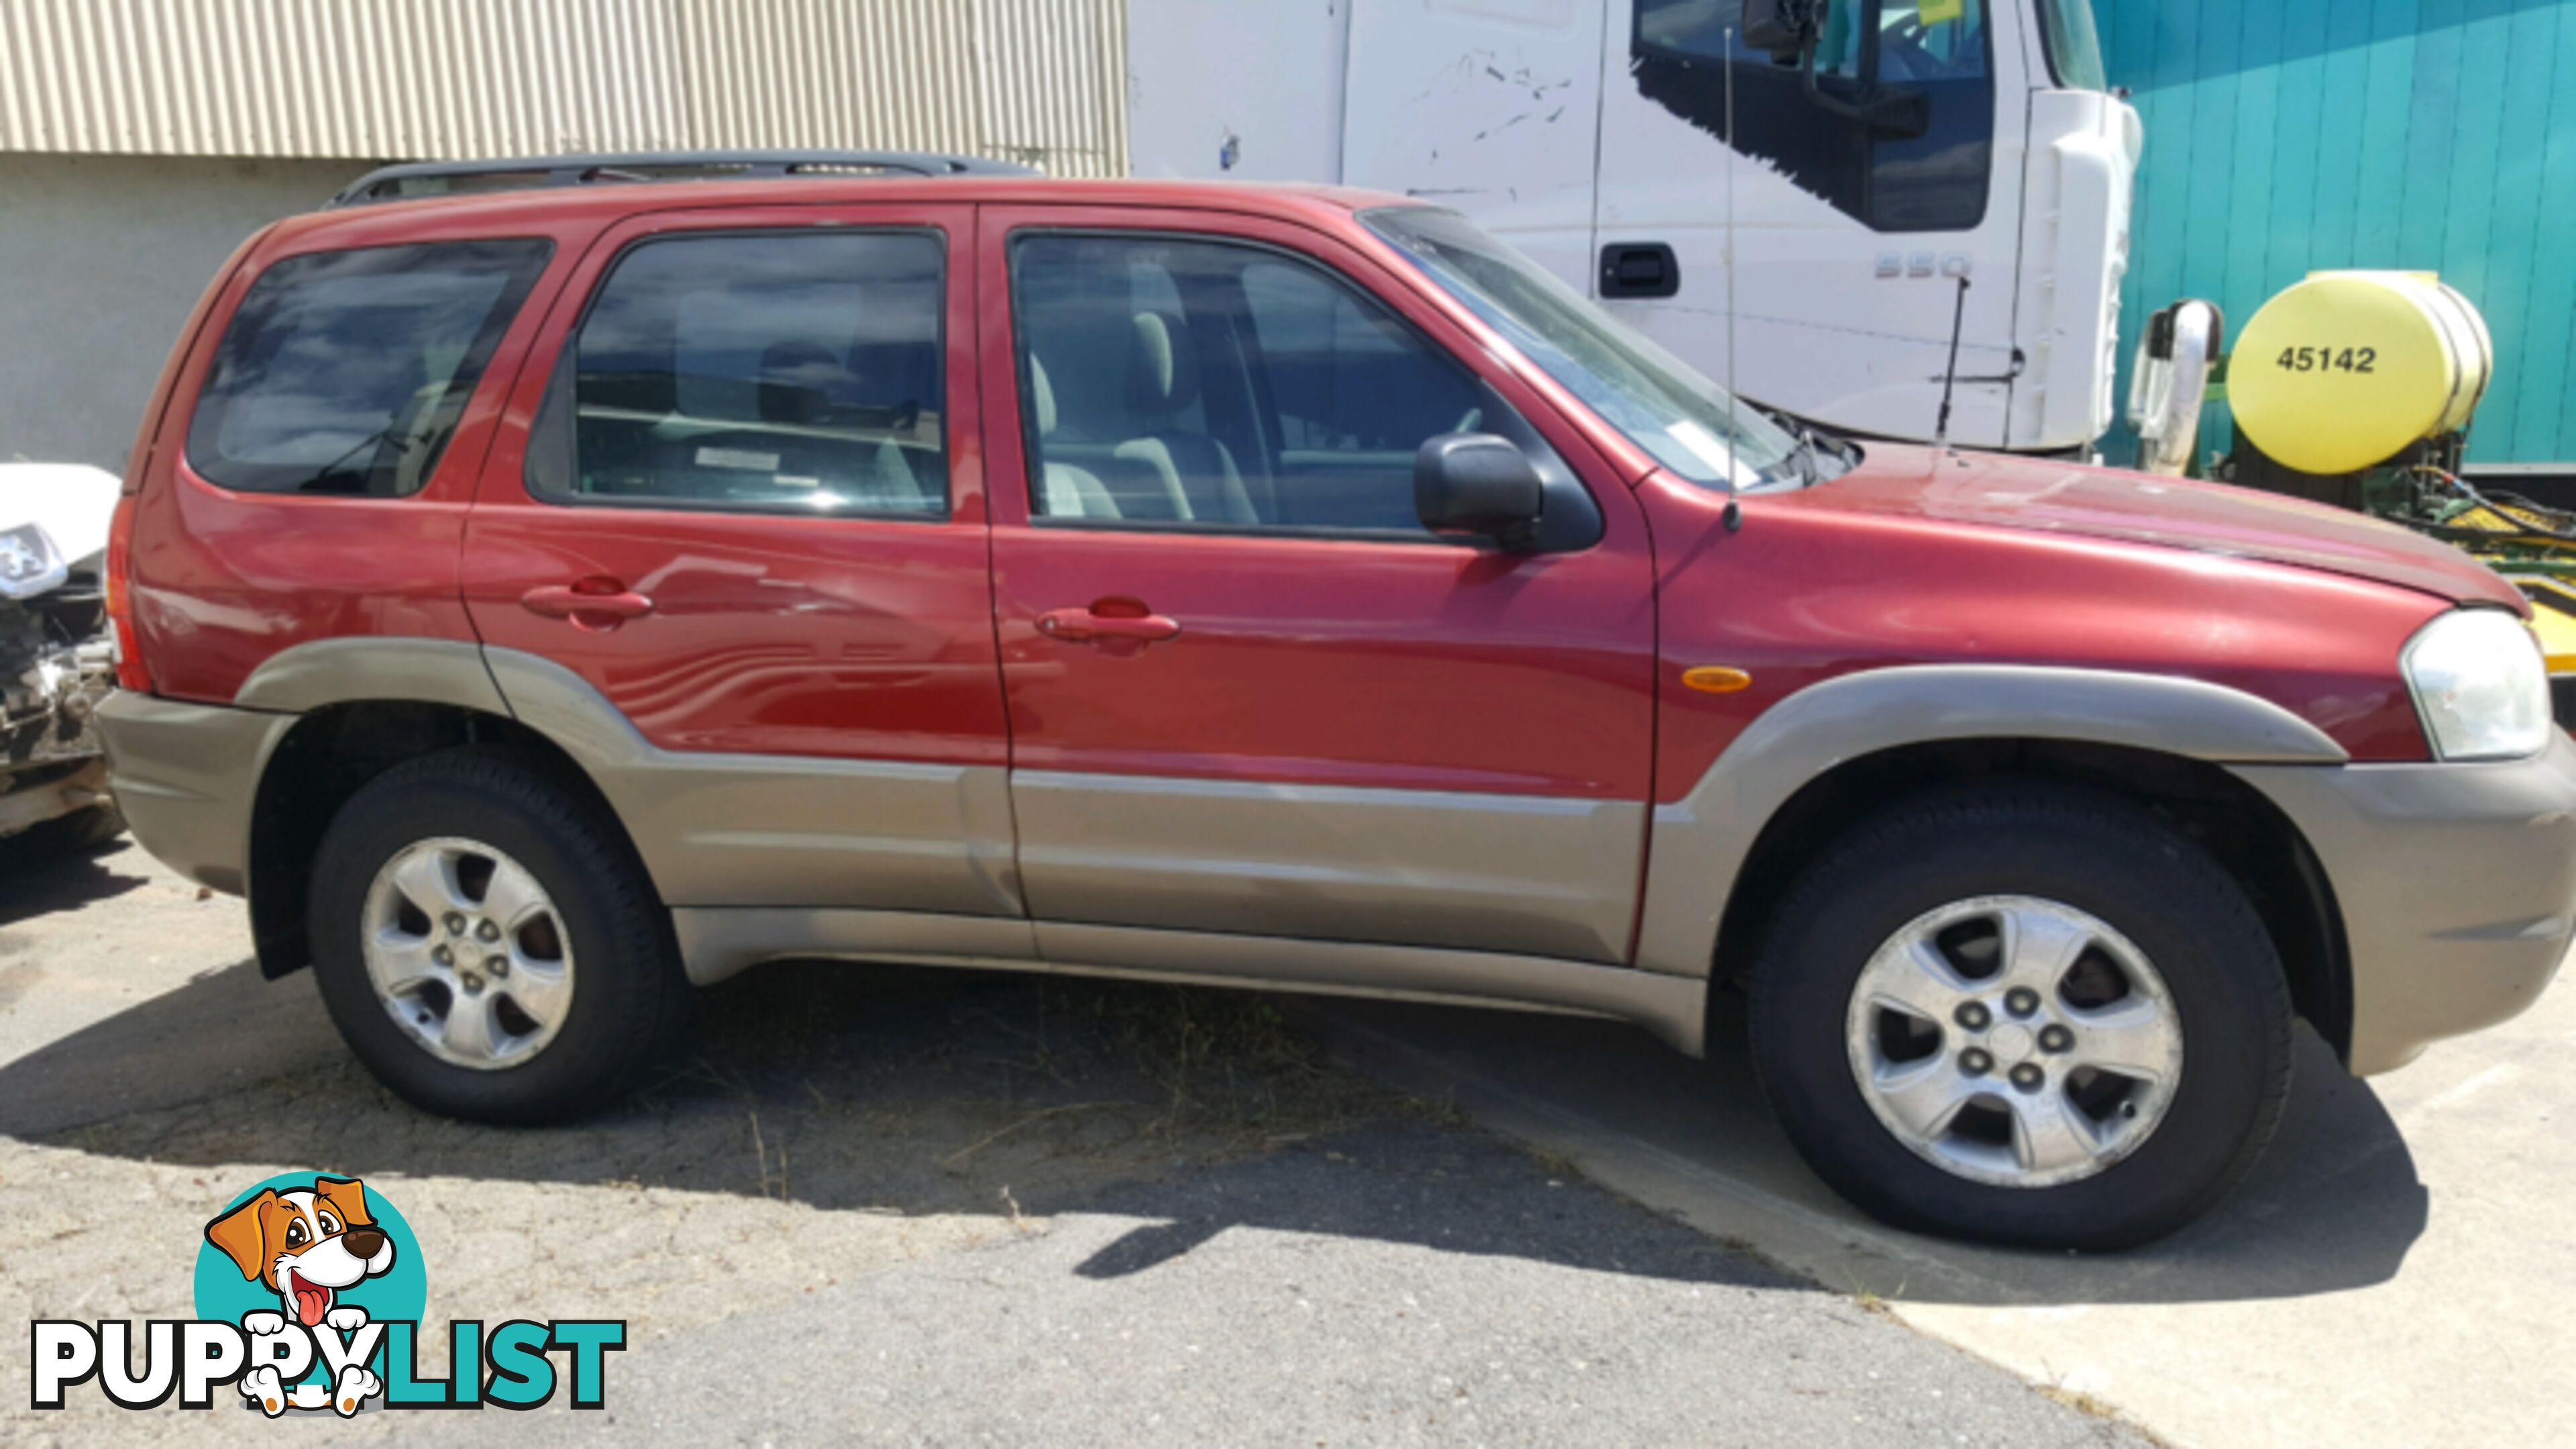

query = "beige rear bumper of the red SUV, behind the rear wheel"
[98,691,297,895]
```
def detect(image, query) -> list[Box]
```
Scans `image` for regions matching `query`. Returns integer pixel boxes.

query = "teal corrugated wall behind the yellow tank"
[2094,0,2576,464]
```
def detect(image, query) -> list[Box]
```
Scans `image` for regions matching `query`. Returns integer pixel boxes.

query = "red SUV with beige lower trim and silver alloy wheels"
[103,152,2576,1248]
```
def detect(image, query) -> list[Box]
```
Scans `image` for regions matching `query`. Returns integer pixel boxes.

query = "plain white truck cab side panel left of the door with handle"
[1342,0,1615,286]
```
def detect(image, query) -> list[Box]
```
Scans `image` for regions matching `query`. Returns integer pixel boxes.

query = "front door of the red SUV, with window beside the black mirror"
[979,206,1654,962]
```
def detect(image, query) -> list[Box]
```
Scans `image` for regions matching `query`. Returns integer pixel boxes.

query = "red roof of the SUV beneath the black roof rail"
[263,173,1411,255]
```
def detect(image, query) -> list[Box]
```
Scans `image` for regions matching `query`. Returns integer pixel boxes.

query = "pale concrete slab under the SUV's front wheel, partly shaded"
[1316,977,2576,1449]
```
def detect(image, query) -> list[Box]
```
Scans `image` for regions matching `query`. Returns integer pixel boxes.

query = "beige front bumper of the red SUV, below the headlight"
[2236,730,2576,1075]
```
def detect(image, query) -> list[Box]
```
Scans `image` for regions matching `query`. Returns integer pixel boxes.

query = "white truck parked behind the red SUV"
[1128,0,2141,453]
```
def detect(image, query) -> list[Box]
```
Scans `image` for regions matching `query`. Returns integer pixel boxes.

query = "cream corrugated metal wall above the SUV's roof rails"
[0,0,1126,175]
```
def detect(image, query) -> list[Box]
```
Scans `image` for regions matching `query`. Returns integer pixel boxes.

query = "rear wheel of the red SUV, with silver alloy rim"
[309,748,688,1122]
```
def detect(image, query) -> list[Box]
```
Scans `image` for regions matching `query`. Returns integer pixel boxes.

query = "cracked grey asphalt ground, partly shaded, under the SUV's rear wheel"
[0,846,2133,1446]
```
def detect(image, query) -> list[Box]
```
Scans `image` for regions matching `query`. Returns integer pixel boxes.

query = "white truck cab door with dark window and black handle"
[1592,0,2025,446]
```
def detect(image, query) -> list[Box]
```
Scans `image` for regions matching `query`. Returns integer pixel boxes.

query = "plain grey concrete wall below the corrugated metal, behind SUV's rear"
[0,152,374,472]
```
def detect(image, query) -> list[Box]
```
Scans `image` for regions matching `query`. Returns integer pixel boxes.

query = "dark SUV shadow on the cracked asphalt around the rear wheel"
[0,959,1811,1289]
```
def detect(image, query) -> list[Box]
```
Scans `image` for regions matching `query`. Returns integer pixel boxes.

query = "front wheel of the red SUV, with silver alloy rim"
[1752,786,2290,1248]
